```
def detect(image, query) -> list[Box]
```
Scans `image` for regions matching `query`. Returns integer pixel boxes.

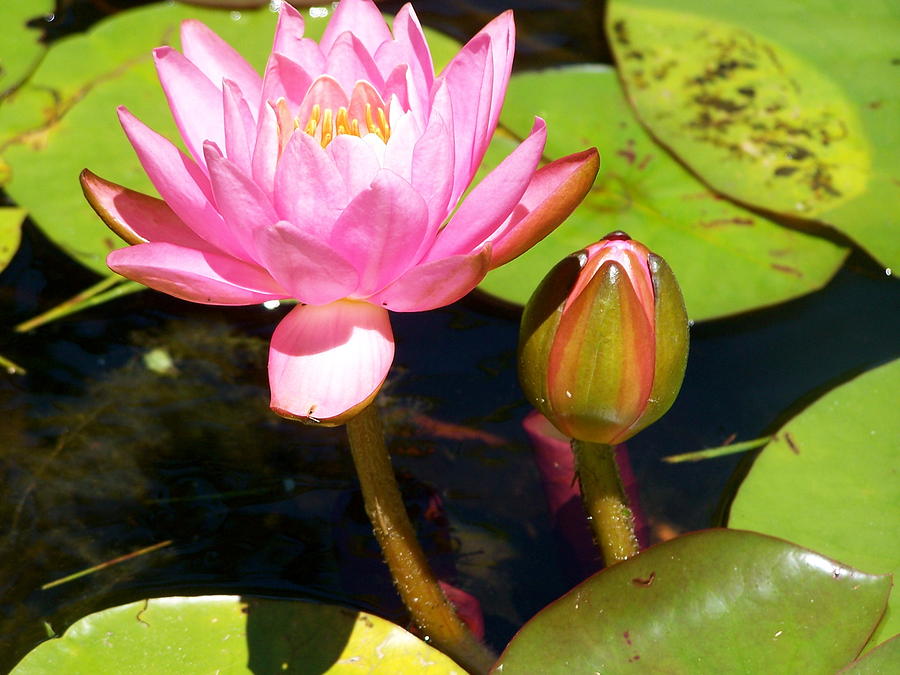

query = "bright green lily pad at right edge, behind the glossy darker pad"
[729,360,900,643]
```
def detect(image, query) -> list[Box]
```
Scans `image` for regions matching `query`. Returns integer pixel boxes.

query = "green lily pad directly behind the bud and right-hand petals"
[483,66,846,320]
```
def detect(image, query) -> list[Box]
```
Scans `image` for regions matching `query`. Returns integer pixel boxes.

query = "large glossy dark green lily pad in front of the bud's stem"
[492,530,891,675]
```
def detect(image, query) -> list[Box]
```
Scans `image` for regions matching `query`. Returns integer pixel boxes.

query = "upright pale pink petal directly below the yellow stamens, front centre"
[275,131,347,238]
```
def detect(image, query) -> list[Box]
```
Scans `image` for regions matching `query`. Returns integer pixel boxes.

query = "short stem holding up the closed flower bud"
[572,439,639,566]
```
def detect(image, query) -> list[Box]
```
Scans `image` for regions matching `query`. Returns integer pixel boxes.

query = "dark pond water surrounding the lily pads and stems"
[0,0,900,669]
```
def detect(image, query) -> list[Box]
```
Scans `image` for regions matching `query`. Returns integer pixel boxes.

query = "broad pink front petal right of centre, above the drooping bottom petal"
[331,169,428,297]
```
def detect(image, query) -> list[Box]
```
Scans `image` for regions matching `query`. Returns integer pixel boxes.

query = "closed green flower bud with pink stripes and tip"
[519,232,688,444]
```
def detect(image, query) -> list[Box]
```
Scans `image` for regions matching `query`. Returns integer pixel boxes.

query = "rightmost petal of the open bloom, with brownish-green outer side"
[491,148,600,269]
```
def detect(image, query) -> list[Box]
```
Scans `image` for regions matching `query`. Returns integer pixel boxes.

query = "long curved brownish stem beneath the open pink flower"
[347,403,496,673]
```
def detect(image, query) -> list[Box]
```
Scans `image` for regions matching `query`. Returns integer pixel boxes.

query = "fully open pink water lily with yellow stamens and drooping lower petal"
[82,0,599,423]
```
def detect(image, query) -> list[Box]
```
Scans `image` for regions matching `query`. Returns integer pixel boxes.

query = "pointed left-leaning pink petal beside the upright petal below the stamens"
[204,143,278,262]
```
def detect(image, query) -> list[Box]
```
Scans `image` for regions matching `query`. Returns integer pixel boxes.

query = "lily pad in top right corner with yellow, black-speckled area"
[607,0,900,274]
